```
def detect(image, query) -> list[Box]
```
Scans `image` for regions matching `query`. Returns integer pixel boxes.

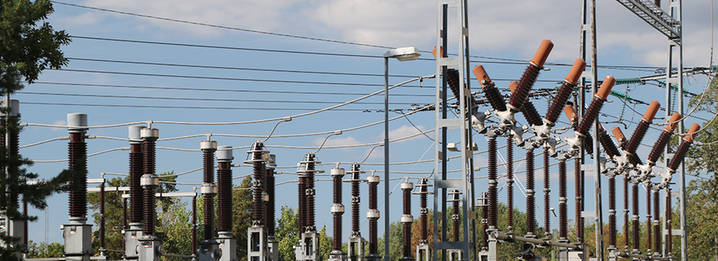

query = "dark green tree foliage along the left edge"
[0,0,71,260]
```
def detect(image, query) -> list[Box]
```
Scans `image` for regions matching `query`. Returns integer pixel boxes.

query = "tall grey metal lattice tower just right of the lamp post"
[432,0,478,256]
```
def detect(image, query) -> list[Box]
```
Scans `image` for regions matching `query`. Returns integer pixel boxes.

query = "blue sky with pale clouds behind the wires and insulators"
[13,0,711,248]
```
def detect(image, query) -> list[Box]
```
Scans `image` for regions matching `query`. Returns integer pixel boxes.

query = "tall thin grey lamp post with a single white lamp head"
[384,47,421,261]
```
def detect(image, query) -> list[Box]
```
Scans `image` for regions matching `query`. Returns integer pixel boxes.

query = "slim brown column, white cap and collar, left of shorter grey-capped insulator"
[200,140,217,240]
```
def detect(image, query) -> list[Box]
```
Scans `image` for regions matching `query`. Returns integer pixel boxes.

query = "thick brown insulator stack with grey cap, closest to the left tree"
[68,132,87,217]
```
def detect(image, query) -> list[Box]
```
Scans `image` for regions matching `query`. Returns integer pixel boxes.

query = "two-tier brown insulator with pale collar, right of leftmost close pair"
[142,134,157,235]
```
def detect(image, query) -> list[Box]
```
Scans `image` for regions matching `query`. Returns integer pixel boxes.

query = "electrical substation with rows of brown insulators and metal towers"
[0,0,710,261]
